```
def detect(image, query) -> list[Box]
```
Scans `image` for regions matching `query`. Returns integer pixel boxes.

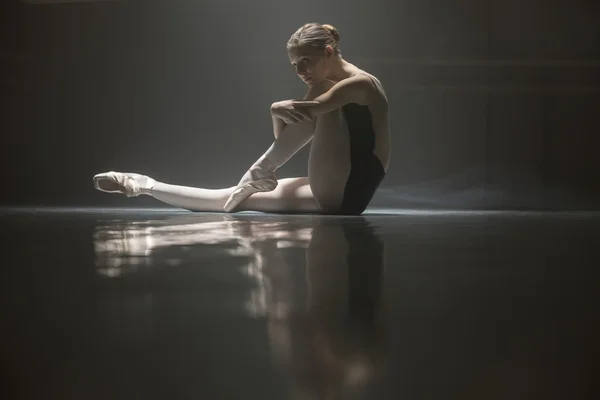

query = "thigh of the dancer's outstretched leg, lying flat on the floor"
[239,177,321,214]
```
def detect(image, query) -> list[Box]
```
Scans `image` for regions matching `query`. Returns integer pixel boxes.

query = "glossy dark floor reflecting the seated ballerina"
[0,209,600,400]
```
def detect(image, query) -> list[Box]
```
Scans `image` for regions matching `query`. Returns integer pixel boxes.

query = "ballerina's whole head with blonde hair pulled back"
[287,22,342,85]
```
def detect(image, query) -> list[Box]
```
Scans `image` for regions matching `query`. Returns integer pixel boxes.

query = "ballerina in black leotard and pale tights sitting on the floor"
[93,23,391,215]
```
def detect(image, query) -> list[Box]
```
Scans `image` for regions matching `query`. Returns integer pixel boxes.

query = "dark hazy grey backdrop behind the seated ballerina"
[0,0,600,209]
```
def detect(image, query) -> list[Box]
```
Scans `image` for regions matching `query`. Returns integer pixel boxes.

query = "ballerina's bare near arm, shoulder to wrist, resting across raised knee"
[294,75,376,117]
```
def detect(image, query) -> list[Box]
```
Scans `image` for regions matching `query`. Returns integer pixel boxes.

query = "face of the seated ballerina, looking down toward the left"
[288,46,333,86]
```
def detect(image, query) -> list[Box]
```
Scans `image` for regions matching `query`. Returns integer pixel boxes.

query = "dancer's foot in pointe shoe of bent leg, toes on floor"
[223,159,277,212]
